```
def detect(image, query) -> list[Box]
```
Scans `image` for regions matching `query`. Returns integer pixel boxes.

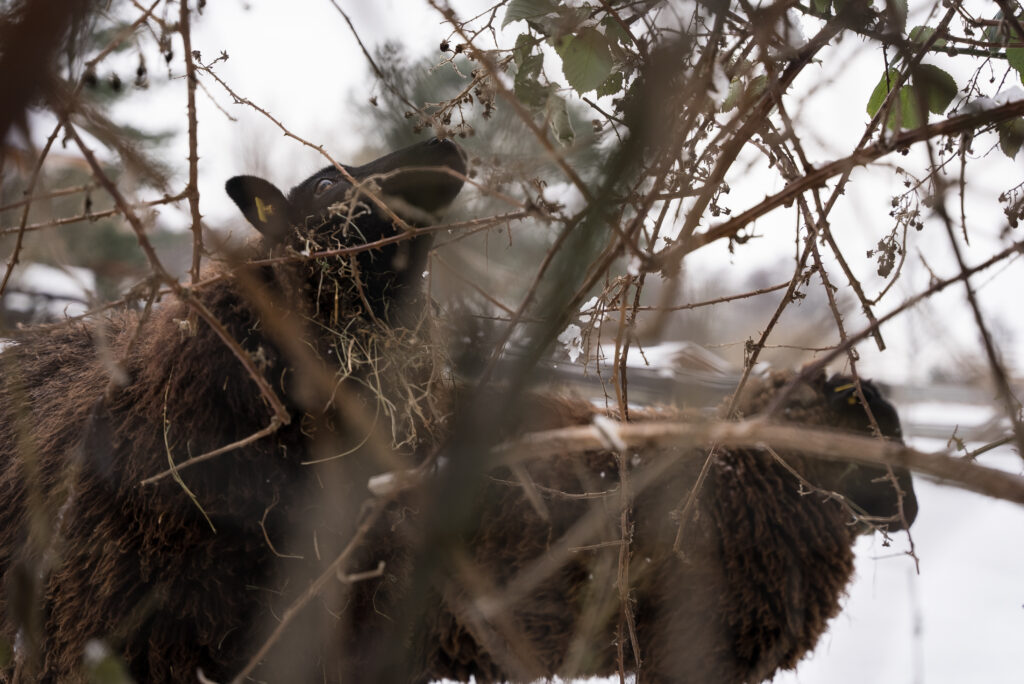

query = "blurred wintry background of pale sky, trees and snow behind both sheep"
[0,0,1024,684]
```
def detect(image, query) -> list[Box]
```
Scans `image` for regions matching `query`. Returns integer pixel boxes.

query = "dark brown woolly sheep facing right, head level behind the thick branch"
[344,374,916,684]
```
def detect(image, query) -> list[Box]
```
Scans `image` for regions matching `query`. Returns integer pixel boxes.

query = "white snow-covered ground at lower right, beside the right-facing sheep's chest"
[775,442,1024,684]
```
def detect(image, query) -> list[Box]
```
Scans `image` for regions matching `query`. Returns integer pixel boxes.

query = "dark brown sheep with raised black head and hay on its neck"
[0,140,466,682]
